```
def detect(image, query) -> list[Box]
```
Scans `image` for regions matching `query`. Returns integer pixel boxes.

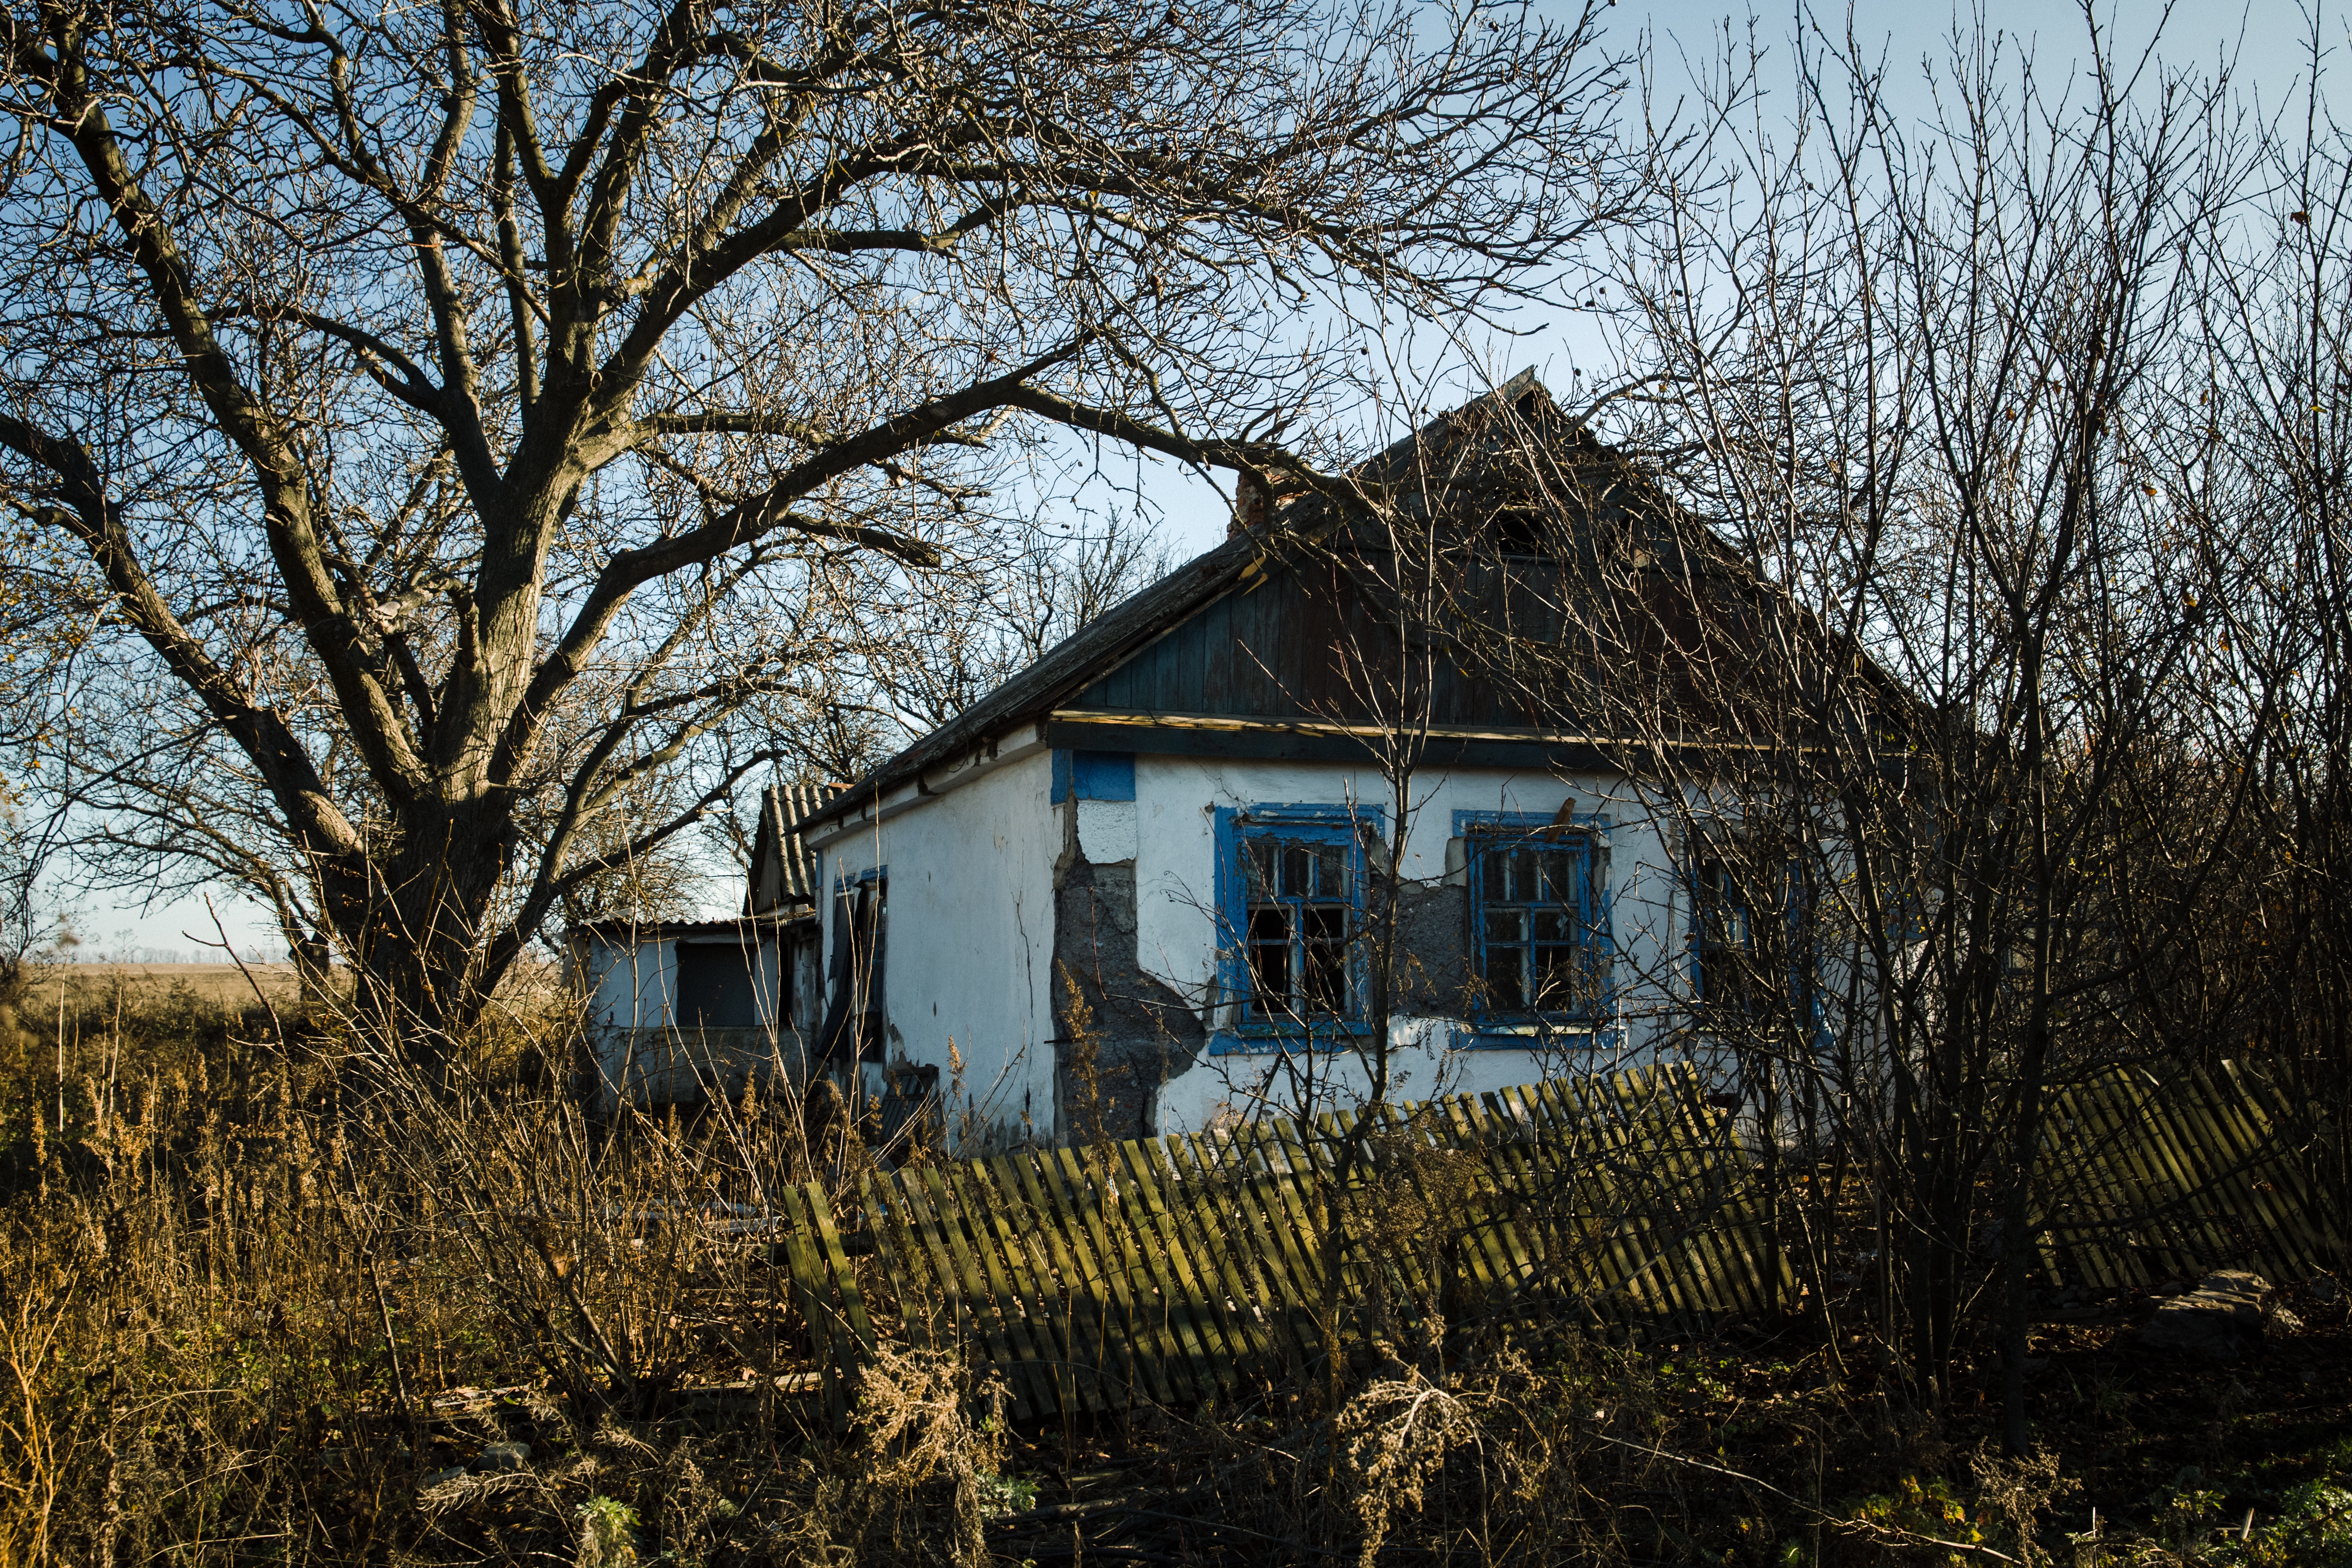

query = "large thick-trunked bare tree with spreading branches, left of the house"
[0,0,1635,1072]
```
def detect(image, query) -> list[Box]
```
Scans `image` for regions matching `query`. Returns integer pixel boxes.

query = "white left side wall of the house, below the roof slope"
[821,750,1063,1140]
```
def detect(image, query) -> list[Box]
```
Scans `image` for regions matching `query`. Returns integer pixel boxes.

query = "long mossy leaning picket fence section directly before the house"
[783,1065,1795,1417]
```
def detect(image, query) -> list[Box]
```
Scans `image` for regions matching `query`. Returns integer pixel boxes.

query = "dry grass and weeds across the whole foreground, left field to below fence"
[0,985,2317,1568]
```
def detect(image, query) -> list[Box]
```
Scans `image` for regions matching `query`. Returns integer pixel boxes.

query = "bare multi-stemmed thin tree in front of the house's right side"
[1411,16,2340,1451]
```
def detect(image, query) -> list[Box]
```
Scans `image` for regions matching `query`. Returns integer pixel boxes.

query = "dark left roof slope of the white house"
[792,369,1543,830]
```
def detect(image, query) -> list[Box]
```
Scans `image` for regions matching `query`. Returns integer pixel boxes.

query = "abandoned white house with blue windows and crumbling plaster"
[797,374,1816,1147]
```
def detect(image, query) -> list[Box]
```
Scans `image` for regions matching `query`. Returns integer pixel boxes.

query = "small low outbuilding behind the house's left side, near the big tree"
[567,785,823,1112]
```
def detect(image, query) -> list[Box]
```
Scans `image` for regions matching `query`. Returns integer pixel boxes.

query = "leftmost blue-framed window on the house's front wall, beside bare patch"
[1211,804,1383,1051]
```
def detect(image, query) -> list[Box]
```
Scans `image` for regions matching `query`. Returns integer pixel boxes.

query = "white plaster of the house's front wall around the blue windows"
[1119,757,1682,1133]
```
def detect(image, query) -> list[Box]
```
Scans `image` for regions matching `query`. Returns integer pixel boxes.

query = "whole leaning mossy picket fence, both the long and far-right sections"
[781,1065,2343,1417]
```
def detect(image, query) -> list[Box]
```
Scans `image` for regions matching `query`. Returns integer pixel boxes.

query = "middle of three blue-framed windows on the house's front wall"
[1453,811,1611,1025]
